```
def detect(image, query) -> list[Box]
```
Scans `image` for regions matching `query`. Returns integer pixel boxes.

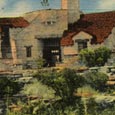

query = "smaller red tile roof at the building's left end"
[0,17,29,27]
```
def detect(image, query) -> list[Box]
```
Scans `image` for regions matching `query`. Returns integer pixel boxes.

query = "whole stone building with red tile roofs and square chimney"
[0,0,115,70]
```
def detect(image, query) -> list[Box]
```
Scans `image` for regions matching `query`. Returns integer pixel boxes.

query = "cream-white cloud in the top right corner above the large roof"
[97,0,115,11]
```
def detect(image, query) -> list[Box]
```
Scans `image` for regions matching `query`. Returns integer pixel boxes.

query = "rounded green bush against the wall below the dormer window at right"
[80,47,111,67]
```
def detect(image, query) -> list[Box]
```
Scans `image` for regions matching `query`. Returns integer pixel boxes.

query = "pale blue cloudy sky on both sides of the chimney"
[0,0,115,17]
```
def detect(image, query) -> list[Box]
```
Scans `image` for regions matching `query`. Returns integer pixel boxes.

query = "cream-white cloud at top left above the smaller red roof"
[0,0,32,17]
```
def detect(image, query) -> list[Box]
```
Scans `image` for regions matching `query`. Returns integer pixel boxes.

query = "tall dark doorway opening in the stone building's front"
[43,38,61,67]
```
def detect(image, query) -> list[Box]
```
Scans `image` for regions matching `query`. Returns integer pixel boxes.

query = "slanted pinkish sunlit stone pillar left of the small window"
[10,39,17,64]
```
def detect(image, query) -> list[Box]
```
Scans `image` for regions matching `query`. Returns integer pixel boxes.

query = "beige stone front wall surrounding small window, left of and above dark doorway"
[10,10,67,63]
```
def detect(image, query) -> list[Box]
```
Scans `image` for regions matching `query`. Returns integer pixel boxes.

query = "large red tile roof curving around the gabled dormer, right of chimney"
[61,11,115,46]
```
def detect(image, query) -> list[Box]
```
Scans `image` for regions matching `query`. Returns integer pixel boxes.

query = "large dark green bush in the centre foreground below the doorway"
[35,68,84,101]
